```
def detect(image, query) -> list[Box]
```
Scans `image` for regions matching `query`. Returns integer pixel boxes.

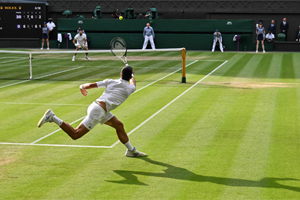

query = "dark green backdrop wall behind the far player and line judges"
[57,18,255,51]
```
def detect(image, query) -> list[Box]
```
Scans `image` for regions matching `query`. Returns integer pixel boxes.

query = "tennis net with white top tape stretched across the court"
[0,48,185,81]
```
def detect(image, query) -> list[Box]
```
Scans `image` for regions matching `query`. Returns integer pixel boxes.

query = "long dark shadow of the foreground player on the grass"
[107,157,300,192]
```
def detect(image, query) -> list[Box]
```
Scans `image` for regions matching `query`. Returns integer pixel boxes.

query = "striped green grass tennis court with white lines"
[0,51,300,199]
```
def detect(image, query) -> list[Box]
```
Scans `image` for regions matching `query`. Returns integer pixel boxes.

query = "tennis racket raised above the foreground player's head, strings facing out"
[110,37,128,66]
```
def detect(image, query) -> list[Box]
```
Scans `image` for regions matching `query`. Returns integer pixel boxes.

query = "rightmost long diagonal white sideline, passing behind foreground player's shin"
[110,60,228,148]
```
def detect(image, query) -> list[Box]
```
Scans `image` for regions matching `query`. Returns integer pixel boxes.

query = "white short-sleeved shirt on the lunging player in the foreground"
[97,78,135,112]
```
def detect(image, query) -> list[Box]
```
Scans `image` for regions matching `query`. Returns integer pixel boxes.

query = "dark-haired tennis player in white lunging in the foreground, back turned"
[38,66,146,157]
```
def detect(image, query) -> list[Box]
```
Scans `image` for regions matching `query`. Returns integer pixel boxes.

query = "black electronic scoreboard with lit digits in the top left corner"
[0,3,46,38]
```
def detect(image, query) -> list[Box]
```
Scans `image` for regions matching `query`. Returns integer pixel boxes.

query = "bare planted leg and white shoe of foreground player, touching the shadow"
[105,113,146,157]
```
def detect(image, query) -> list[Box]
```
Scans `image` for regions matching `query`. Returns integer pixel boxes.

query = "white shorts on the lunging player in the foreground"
[81,102,114,130]
